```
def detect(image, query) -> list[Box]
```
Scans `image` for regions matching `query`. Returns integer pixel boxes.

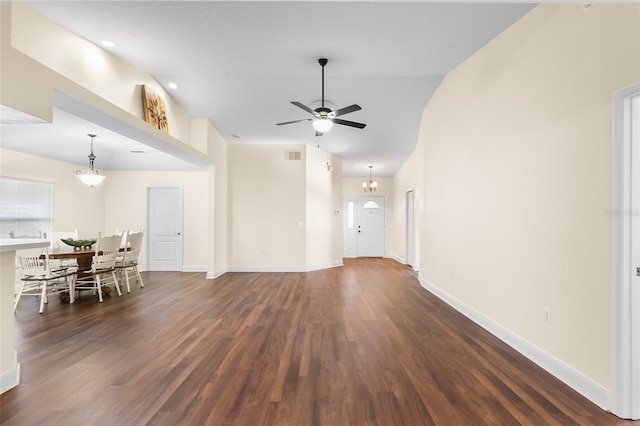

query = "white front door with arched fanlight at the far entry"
[356,197,385,257]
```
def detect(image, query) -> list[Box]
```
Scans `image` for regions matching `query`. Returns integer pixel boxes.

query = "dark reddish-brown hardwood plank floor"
[0,259,632,426]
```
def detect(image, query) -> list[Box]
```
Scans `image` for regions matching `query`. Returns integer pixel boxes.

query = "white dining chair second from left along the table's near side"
[75,233,122,303]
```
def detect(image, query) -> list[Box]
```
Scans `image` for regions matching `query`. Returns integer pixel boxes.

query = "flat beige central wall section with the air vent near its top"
[227,144,307,270]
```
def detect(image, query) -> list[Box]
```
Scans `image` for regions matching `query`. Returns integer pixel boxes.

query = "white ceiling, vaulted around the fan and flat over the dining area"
[1,1,533,176]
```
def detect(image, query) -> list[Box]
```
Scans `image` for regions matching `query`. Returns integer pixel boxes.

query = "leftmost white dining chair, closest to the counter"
[13,247,77,313]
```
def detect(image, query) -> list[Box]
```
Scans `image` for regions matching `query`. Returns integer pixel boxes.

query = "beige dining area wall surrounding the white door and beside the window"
[0,149,209,271]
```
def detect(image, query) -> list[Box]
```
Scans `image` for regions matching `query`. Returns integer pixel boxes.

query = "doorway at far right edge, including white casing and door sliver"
[610,85,640,419]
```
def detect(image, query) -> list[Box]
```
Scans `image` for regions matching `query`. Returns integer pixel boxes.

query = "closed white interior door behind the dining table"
[147,188,182,271]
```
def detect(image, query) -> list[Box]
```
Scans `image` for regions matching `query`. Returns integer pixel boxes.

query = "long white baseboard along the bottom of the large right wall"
[418,275,611,411]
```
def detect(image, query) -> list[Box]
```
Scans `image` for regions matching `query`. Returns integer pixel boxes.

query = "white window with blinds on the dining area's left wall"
[0,178,53,239]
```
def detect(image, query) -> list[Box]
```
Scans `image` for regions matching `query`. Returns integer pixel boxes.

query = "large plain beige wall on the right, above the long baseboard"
[418,4,640,390]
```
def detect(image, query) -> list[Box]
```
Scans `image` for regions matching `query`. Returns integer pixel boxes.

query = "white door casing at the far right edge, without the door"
[608,84,640,419]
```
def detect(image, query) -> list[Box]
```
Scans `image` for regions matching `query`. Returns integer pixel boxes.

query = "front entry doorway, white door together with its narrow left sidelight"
[344,196,385,257]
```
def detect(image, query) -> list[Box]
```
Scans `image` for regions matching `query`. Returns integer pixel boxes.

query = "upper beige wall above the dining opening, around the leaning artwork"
[0,2,206,160]
